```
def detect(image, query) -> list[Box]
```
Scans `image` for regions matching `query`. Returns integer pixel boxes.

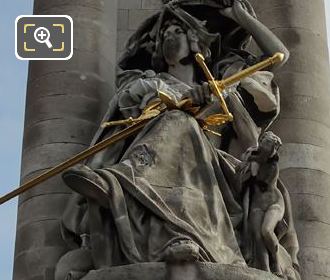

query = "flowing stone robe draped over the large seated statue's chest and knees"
[59,68,284,268]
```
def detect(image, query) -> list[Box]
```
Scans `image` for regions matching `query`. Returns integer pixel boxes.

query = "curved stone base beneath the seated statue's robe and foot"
[82,263,281,280]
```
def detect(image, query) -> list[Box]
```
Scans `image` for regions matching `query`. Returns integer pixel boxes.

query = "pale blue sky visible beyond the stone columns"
[0,0,330,280]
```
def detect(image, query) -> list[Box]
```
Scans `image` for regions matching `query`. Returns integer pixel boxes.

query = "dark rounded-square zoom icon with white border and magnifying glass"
[15,15,73,60]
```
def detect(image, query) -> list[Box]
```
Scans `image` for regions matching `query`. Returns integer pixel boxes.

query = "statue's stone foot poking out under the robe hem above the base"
[165,240,199,262]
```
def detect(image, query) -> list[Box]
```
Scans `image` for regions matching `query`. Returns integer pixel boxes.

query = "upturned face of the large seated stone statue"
[162,24,190,65]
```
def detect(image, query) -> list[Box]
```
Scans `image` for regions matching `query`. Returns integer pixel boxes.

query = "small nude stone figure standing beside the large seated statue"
[238,131,285,275]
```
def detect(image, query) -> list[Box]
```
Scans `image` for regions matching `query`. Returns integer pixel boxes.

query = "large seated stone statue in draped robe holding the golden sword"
[56,0,295,280]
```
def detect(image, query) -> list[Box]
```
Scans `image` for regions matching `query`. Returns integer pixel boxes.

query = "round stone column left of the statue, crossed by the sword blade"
[14,0,117,280]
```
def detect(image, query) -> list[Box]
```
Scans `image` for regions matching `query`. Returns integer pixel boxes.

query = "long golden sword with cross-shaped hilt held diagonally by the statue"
[0,53,284,205]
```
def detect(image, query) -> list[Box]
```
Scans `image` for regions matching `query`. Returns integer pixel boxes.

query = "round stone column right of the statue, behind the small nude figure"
[251,0,330,280]
